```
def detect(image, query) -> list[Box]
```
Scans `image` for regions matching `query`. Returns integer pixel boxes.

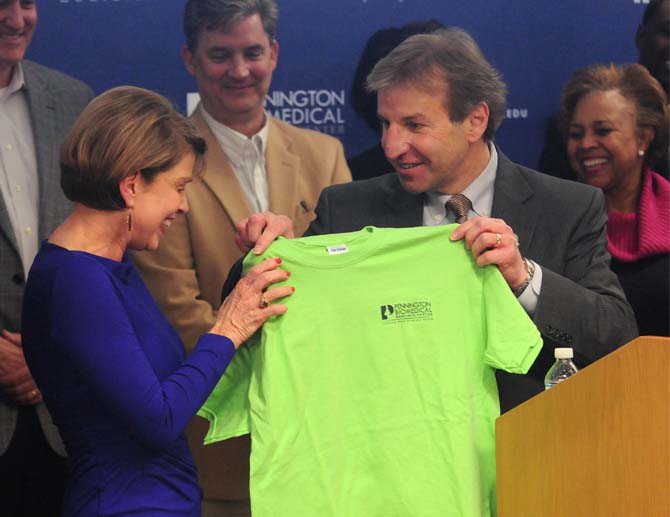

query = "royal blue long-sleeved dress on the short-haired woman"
[23,242,235,516]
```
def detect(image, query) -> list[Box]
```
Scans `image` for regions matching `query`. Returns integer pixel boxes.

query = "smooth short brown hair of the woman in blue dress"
[60,86,206,210]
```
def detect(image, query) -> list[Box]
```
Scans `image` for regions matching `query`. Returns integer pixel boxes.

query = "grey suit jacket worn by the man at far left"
[0,60,93,456]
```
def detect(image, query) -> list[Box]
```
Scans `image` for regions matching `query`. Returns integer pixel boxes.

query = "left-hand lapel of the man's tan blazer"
[192,106,253,224]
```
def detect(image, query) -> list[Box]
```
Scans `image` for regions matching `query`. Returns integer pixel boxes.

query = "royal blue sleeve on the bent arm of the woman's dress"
[50,258,235,448]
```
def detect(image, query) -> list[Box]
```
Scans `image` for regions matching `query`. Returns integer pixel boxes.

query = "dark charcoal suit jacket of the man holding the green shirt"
[305,151,637,411]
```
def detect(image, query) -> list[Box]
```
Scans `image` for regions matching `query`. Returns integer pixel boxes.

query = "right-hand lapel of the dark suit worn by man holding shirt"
[491,149,541,255]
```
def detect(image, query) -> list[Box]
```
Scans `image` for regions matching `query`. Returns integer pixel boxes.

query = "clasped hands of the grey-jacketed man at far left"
[0,330,42,405]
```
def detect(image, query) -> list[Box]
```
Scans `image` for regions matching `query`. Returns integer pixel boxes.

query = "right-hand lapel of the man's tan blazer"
[265,117,302,217]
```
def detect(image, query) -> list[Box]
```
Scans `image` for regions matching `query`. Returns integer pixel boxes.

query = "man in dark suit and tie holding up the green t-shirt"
[237,28,637,411]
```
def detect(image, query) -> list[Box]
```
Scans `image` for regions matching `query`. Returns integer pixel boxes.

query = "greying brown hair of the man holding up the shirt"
[366,27,507,141]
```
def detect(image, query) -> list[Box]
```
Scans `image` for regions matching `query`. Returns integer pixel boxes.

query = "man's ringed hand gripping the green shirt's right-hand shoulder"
[451,217,528,290]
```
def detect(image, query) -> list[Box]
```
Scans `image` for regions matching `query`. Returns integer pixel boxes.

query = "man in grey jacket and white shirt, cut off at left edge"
[0,0,93,516]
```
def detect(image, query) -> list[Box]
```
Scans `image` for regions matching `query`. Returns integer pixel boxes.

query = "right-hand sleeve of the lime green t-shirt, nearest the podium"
[482,266,542,373]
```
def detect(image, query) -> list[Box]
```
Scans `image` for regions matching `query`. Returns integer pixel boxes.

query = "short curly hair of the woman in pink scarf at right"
[561,63,668,165]
